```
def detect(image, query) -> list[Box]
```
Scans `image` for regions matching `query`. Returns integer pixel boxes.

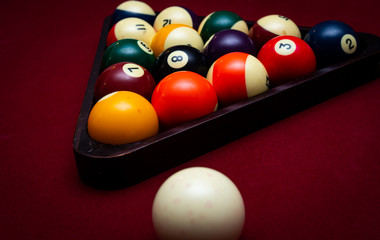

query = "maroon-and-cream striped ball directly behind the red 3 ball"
[248,14,301,49]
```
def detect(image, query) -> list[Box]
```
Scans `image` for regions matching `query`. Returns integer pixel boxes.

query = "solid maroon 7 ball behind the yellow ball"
[94,62,156,101]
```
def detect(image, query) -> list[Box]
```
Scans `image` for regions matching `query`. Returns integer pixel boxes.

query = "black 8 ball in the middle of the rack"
[154,45,208,81]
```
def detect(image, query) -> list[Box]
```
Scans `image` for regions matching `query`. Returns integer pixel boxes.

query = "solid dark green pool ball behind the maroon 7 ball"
[101,39,156,72]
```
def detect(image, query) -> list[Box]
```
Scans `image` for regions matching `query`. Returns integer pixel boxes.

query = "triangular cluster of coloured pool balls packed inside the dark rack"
[88,1,359,145]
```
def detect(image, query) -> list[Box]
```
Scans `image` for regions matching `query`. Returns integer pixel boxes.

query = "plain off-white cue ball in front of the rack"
[152,167,245,240]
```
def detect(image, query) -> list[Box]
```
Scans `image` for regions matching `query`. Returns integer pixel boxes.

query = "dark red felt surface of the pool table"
[0,0,380,240]
